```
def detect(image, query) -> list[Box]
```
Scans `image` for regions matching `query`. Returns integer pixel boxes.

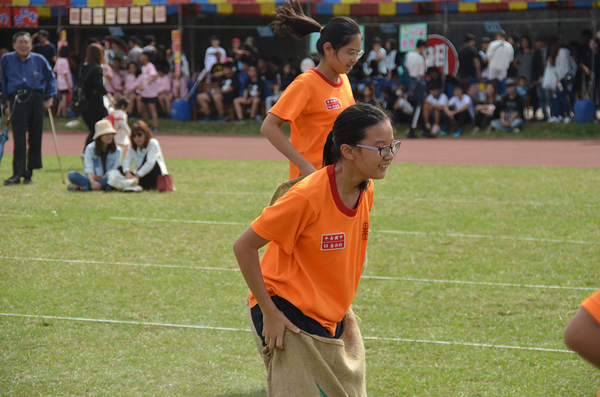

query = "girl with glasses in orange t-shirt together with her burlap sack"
[233,103,400,397]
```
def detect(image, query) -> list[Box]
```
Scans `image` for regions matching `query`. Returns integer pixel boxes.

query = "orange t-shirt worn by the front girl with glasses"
[250,165,373,336]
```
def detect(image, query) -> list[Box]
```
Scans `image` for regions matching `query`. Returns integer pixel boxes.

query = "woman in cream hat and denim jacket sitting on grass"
[68,120,121,191]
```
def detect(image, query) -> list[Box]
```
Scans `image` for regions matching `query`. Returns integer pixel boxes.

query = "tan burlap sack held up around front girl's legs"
[250,309,367,397]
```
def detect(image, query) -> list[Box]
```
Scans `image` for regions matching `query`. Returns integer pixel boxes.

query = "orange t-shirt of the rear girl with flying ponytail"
[269,69,354,179]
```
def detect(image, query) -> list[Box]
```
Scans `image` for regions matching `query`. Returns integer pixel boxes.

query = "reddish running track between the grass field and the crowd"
[4,131,600,167]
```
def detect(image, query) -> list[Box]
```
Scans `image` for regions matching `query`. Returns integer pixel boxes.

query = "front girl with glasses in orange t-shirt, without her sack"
[233,103,400,349]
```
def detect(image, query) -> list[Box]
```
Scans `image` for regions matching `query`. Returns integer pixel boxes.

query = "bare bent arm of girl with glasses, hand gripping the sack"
[233,227,300,349]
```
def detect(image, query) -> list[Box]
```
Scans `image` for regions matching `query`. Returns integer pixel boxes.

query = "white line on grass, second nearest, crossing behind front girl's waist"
[0,256,597,291]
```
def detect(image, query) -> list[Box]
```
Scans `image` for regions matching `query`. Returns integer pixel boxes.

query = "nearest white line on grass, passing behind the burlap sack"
[0,313,574,354]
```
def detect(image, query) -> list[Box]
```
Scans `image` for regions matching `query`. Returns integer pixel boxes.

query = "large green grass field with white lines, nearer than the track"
[0,154,600,397]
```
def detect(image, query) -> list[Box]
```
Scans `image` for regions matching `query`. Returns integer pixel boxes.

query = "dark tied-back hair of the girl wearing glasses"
[323,102,391,191]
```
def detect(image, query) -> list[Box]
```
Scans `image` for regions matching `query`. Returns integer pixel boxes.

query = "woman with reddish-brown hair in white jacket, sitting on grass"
[123,121,168,192]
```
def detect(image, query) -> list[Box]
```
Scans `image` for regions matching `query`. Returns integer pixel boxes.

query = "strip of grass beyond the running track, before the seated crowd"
[44,114,600,139]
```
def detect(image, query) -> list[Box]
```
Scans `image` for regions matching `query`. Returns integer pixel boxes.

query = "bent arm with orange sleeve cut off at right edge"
[565,290,600,397]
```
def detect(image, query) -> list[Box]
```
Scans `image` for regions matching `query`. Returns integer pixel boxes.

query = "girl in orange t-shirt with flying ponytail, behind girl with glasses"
[260,0,364,179]
